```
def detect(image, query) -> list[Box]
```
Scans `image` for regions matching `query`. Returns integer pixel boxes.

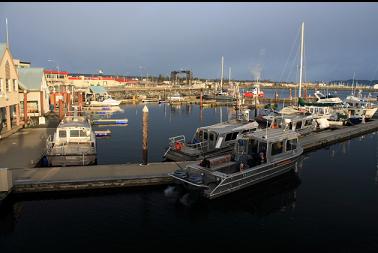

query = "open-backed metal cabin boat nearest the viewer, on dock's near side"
[168,129,303,199]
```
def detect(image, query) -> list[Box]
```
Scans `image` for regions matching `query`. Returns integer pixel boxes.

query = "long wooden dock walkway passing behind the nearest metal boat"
[0,119,378,199]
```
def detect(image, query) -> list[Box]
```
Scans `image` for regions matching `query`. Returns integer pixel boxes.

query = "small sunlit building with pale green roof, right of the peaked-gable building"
[18,68,50,116]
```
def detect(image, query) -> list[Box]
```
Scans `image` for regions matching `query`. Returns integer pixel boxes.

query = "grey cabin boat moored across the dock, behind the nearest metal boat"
[163,113,259,161]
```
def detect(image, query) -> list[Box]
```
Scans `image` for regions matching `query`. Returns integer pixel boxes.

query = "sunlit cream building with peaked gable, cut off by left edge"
[0,43,20,134]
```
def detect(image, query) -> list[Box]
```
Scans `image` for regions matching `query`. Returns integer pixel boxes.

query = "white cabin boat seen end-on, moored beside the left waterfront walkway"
[46,115,97,166]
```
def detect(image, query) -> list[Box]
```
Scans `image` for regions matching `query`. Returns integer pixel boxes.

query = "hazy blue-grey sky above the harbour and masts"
[0,2,378,82]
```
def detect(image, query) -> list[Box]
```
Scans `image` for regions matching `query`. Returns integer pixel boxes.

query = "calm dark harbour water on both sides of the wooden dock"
[0,104,378,253]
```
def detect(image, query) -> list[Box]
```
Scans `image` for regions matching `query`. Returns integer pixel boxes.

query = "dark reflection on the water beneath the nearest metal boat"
[165,165,301,217]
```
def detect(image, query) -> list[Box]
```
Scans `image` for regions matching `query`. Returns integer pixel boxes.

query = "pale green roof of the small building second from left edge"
[18,68,43,91]
